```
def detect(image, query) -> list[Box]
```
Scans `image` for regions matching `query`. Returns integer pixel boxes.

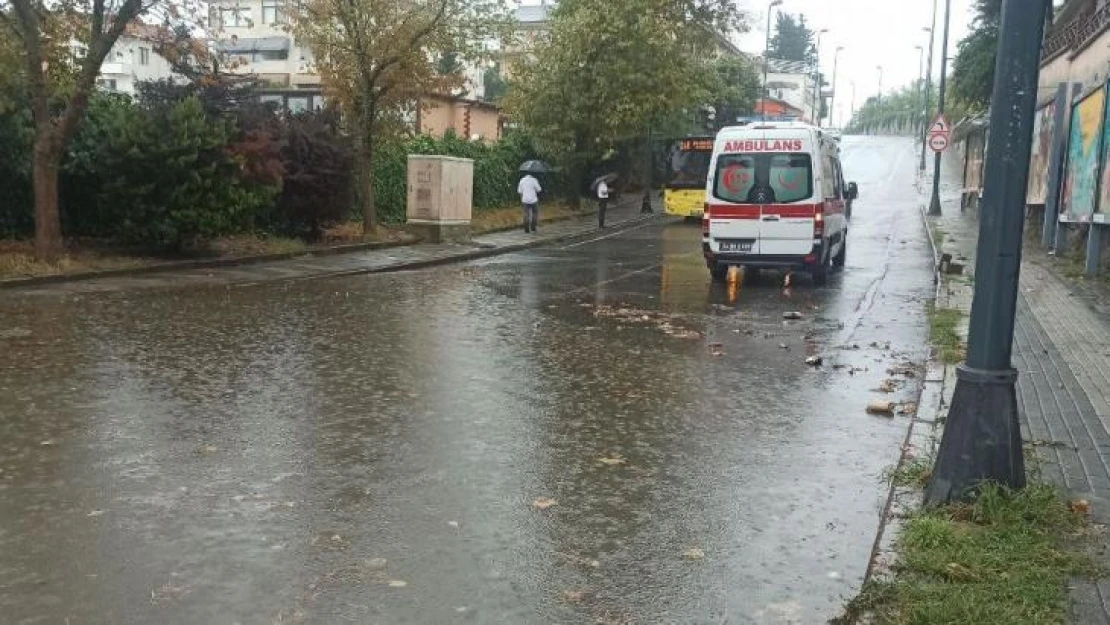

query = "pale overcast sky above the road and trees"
[510,0,972,127]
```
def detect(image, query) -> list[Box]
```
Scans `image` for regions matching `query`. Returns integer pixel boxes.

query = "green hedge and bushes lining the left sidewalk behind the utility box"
[0,84,559,242]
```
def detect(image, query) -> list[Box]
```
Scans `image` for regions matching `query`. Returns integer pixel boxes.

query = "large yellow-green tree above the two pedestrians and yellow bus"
[506,0,741,197]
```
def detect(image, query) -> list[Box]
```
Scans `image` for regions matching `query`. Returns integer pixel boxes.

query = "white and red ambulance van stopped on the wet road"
[702,121,858,285]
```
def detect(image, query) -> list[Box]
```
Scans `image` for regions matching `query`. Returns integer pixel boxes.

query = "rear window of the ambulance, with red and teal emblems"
[713,152,814,204]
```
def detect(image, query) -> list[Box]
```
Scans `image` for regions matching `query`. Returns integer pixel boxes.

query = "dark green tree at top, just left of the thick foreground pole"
[951,0,1002,110]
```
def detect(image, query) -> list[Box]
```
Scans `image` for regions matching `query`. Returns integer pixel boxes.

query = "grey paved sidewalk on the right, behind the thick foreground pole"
[929,177,1110,624]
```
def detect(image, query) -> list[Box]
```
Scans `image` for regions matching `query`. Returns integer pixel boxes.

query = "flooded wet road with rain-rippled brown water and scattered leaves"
[0,138,932,625]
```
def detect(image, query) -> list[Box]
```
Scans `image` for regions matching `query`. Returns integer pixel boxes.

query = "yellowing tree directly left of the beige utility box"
[290,0,507,234]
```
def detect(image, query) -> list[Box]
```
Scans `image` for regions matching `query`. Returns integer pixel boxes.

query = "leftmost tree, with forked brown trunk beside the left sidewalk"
[0,0,195,261]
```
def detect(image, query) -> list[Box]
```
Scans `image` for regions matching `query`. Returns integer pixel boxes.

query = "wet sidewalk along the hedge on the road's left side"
[0,195,660,292]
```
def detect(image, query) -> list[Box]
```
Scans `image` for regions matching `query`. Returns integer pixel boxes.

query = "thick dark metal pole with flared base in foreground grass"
[925,0,1045,504]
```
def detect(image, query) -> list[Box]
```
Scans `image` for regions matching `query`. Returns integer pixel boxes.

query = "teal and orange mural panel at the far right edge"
[1060,87,1106,221]
